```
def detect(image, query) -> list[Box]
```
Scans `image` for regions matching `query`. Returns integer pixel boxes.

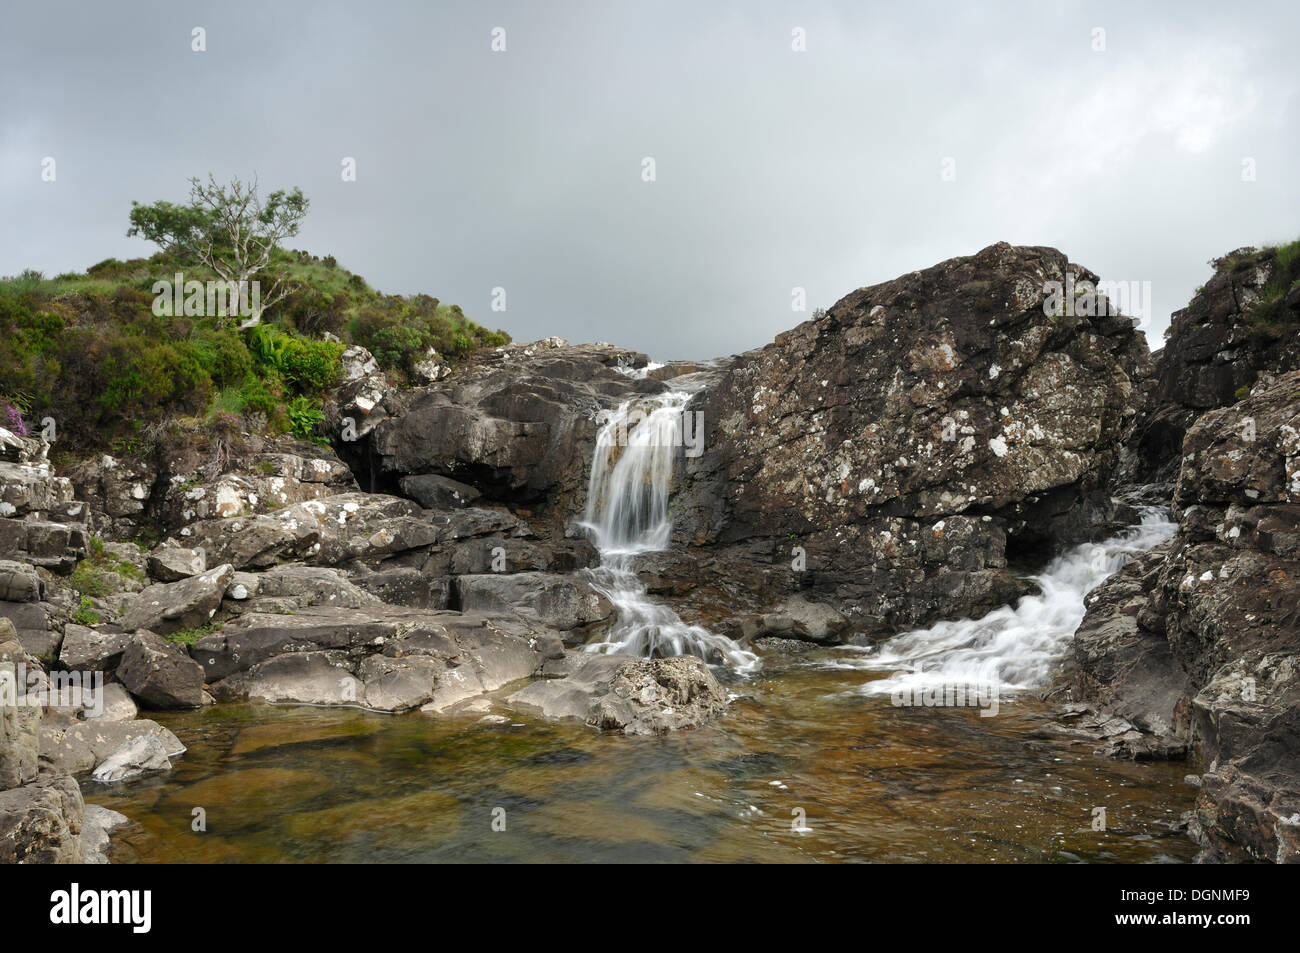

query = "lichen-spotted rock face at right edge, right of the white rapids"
[1071,372,1300,862]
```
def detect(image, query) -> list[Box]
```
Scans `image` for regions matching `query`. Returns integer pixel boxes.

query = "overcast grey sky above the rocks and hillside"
[0,0,1300,360]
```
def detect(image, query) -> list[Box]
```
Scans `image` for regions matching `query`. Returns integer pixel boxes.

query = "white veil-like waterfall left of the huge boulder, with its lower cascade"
[584,391,759,672]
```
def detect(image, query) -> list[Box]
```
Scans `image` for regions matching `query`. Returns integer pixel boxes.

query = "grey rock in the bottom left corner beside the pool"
[0,777,85,863]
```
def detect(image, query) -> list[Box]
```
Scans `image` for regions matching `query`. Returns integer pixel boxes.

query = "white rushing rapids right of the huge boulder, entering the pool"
[829,507,1177,696]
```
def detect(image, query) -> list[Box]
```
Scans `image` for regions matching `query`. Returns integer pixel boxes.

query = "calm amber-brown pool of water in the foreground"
[83,650,1195,863]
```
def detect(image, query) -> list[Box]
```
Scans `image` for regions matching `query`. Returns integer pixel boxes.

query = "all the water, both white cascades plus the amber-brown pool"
[85,393,1195,862]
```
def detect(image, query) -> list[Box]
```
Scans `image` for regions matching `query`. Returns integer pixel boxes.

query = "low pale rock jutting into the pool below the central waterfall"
[507,655,727,735]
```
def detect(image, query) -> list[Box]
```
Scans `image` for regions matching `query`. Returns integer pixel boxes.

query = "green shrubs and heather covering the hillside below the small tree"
[0,180,510,456]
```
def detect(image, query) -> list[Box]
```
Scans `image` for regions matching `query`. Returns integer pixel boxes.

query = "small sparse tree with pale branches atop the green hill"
[126,173,309,328]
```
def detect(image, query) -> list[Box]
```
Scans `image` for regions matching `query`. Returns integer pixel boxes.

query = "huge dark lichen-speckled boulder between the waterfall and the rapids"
[657,244,1147,632]
